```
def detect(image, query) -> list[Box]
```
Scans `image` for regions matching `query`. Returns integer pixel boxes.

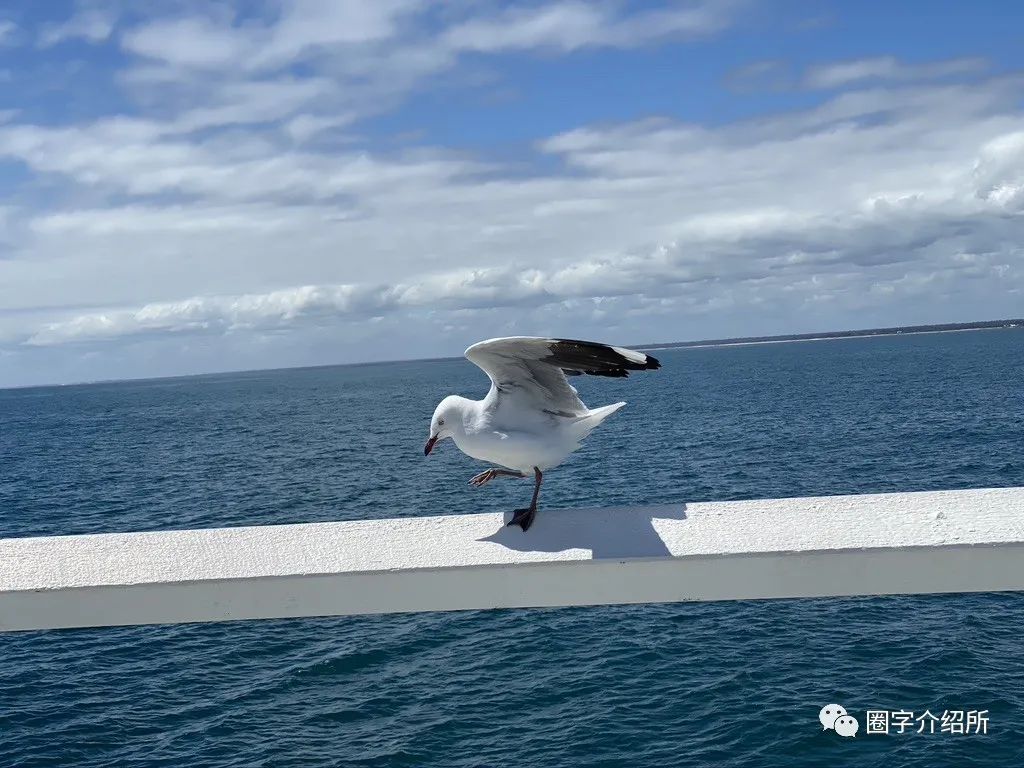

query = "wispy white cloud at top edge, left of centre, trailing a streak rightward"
[110,0,741,150]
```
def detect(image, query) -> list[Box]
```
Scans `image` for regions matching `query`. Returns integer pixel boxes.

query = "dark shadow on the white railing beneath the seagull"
[477,504,686,560]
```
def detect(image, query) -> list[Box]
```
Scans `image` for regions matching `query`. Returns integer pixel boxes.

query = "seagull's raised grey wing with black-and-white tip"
[466,336,662,416]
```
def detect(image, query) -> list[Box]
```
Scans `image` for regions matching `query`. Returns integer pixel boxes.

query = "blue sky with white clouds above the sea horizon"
[0,0,1024,386]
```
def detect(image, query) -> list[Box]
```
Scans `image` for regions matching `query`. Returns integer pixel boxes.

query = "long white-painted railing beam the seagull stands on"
[0,488,1024,631]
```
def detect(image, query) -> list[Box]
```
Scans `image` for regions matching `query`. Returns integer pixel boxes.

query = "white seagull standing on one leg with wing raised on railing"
[423,336,662,531]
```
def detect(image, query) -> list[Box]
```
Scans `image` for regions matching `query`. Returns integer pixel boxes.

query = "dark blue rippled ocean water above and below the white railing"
[0,330,1024,768]
